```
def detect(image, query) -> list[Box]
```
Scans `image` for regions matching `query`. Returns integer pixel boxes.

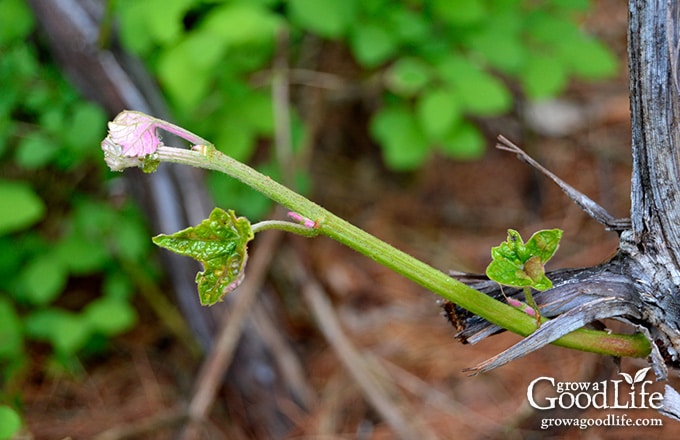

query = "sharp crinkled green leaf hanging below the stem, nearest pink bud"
[153,208,253,305]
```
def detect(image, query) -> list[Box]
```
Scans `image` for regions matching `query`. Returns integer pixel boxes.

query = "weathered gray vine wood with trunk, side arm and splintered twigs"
[444,0,680,384]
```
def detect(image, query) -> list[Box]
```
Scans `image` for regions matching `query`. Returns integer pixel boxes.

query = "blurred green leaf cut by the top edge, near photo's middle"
[288,0,356,38]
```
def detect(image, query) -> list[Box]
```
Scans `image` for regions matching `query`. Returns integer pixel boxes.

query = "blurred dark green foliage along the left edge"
[0,0,153,422]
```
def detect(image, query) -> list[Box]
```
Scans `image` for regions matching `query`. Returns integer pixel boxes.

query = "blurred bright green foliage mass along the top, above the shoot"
[118,0,617,177]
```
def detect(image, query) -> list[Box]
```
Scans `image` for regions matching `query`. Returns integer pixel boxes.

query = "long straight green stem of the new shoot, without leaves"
[153,145,651,357]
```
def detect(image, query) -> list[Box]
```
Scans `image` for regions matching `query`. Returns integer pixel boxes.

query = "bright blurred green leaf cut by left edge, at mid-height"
[0,180,45,235]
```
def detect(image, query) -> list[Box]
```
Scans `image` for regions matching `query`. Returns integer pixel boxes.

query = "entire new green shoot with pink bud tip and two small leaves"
[102,111,650,371]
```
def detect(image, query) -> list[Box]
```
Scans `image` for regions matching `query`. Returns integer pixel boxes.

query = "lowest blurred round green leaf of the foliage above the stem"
[370,106,429,171]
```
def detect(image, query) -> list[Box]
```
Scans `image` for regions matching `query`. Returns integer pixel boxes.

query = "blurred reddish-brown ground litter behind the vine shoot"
[18,1,680,440]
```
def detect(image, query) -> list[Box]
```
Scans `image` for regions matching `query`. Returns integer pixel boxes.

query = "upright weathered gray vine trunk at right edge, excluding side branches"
[619,0,680,365]
